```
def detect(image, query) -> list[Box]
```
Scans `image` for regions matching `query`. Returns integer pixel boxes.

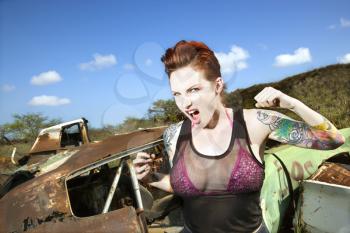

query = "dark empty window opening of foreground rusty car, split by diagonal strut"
[67,160,136,217]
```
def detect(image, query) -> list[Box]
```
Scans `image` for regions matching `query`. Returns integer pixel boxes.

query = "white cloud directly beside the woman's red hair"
[215,45,249,75]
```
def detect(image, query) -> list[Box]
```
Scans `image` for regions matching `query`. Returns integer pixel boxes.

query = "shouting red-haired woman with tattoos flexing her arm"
[134,41,344,233]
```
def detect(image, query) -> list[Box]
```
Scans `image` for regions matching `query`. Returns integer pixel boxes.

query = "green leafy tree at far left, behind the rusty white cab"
[1,113,61,142]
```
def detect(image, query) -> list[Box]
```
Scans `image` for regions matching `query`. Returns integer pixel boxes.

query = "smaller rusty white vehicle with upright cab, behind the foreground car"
[0,118,93,193]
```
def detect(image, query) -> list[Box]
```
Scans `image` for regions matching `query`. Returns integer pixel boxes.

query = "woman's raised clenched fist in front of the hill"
[254,87,297,110]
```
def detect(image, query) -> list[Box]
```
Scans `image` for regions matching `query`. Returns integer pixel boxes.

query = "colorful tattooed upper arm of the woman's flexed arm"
[257,111,344,150]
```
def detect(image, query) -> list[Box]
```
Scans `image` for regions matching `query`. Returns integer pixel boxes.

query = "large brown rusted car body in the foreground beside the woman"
[0,127,181,233]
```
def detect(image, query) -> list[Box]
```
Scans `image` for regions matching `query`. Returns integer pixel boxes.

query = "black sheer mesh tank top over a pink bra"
[170,109,264,233]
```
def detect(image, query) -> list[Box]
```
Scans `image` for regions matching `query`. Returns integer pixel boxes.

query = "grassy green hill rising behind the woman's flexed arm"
[226,64,350,128]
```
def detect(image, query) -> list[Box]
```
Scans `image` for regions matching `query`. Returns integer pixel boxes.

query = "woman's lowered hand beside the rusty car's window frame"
[132,152,155,182]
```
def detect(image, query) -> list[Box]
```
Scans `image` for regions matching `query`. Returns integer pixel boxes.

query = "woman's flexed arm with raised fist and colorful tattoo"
[255,87,345,150]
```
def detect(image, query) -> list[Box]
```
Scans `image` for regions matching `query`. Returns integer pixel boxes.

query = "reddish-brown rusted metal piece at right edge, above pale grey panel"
[310,162,350,187]
